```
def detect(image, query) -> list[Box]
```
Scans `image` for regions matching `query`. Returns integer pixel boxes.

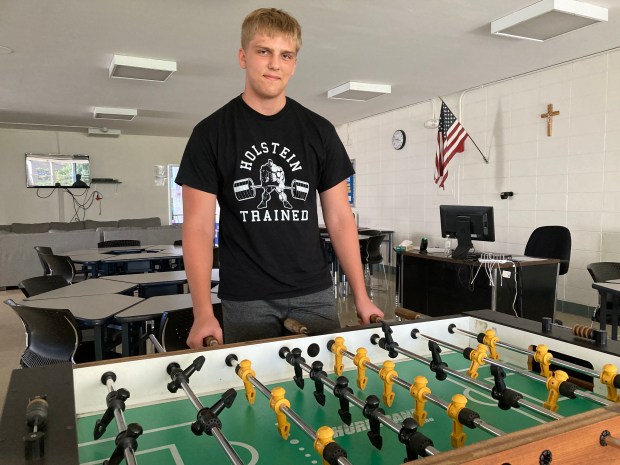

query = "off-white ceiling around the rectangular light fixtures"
[0,0,620,137]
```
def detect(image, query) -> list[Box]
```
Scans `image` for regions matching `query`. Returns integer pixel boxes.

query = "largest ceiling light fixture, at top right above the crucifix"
[491,0,608,42]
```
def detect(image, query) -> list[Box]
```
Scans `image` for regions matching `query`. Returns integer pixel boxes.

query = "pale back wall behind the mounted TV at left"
[0,129,187,224]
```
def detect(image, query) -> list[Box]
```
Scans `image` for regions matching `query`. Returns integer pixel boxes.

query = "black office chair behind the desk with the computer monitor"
[524,226,571,275]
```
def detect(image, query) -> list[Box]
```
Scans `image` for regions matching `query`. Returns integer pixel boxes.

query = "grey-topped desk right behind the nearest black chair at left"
[19,294,144,360]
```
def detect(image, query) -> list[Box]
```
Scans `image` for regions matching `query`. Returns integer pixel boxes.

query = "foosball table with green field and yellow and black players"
[0,310,620,465]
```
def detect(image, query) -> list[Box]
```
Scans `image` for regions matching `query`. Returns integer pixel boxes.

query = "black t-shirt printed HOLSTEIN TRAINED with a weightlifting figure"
[176,96,353,300]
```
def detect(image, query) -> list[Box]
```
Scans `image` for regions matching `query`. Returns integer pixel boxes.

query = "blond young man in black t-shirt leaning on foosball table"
[176,8,383,348]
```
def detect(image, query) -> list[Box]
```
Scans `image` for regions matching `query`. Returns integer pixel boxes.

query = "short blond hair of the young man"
[241,8,301,52]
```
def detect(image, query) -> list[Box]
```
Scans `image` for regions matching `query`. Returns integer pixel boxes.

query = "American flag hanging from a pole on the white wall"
[435,102,468,189]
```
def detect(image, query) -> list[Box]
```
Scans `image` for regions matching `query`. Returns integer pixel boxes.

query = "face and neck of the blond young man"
[239,34,297,100]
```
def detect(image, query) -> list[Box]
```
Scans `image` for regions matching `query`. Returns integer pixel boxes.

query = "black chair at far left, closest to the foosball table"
[4,299,94,368]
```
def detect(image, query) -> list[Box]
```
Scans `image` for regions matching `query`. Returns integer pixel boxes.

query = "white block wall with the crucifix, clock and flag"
[337,51,620,306]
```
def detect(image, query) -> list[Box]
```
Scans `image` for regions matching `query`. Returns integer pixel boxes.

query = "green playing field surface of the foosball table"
[77,353,599,465]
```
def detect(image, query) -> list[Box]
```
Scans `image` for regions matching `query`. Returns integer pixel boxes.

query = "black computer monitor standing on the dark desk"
[439,205,495,259]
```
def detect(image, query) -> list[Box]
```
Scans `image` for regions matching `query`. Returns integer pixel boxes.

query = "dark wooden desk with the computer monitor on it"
[399,252,559,321]
